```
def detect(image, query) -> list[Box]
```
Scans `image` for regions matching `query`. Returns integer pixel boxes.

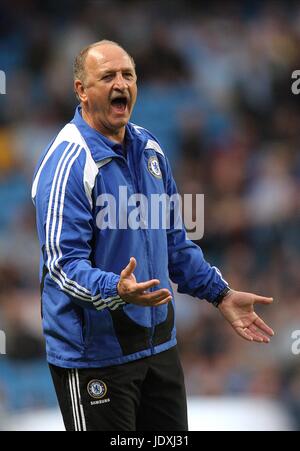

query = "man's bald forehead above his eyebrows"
[85,45,134,72]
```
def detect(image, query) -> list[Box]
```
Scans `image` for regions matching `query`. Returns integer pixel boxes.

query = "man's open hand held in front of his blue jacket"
[118,257,172,306]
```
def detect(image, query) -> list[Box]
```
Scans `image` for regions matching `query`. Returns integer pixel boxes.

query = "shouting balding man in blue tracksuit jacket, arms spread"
[32,41,273,431]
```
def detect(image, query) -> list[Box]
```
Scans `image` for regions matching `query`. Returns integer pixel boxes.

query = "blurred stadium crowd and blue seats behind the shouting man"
[0,0,300,430]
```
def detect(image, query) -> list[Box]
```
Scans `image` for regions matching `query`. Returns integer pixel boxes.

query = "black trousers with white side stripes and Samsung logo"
[49,347,188,431]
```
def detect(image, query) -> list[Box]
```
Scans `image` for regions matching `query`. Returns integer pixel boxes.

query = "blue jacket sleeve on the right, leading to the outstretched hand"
[166,155,228,302]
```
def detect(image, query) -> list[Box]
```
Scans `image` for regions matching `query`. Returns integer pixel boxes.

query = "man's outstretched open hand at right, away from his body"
[218,290,274,343]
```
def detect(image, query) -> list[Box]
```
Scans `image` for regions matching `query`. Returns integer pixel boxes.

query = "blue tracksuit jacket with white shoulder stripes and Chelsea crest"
[32,107,227,368]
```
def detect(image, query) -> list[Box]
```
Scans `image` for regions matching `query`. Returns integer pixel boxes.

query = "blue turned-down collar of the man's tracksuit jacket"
[71,105,146,161]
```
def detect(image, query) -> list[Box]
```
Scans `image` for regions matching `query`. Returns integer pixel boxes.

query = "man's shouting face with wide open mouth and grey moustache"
[79,44,137,132]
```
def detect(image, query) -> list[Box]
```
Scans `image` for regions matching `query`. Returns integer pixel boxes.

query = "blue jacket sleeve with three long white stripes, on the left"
[35,148,125,310]
